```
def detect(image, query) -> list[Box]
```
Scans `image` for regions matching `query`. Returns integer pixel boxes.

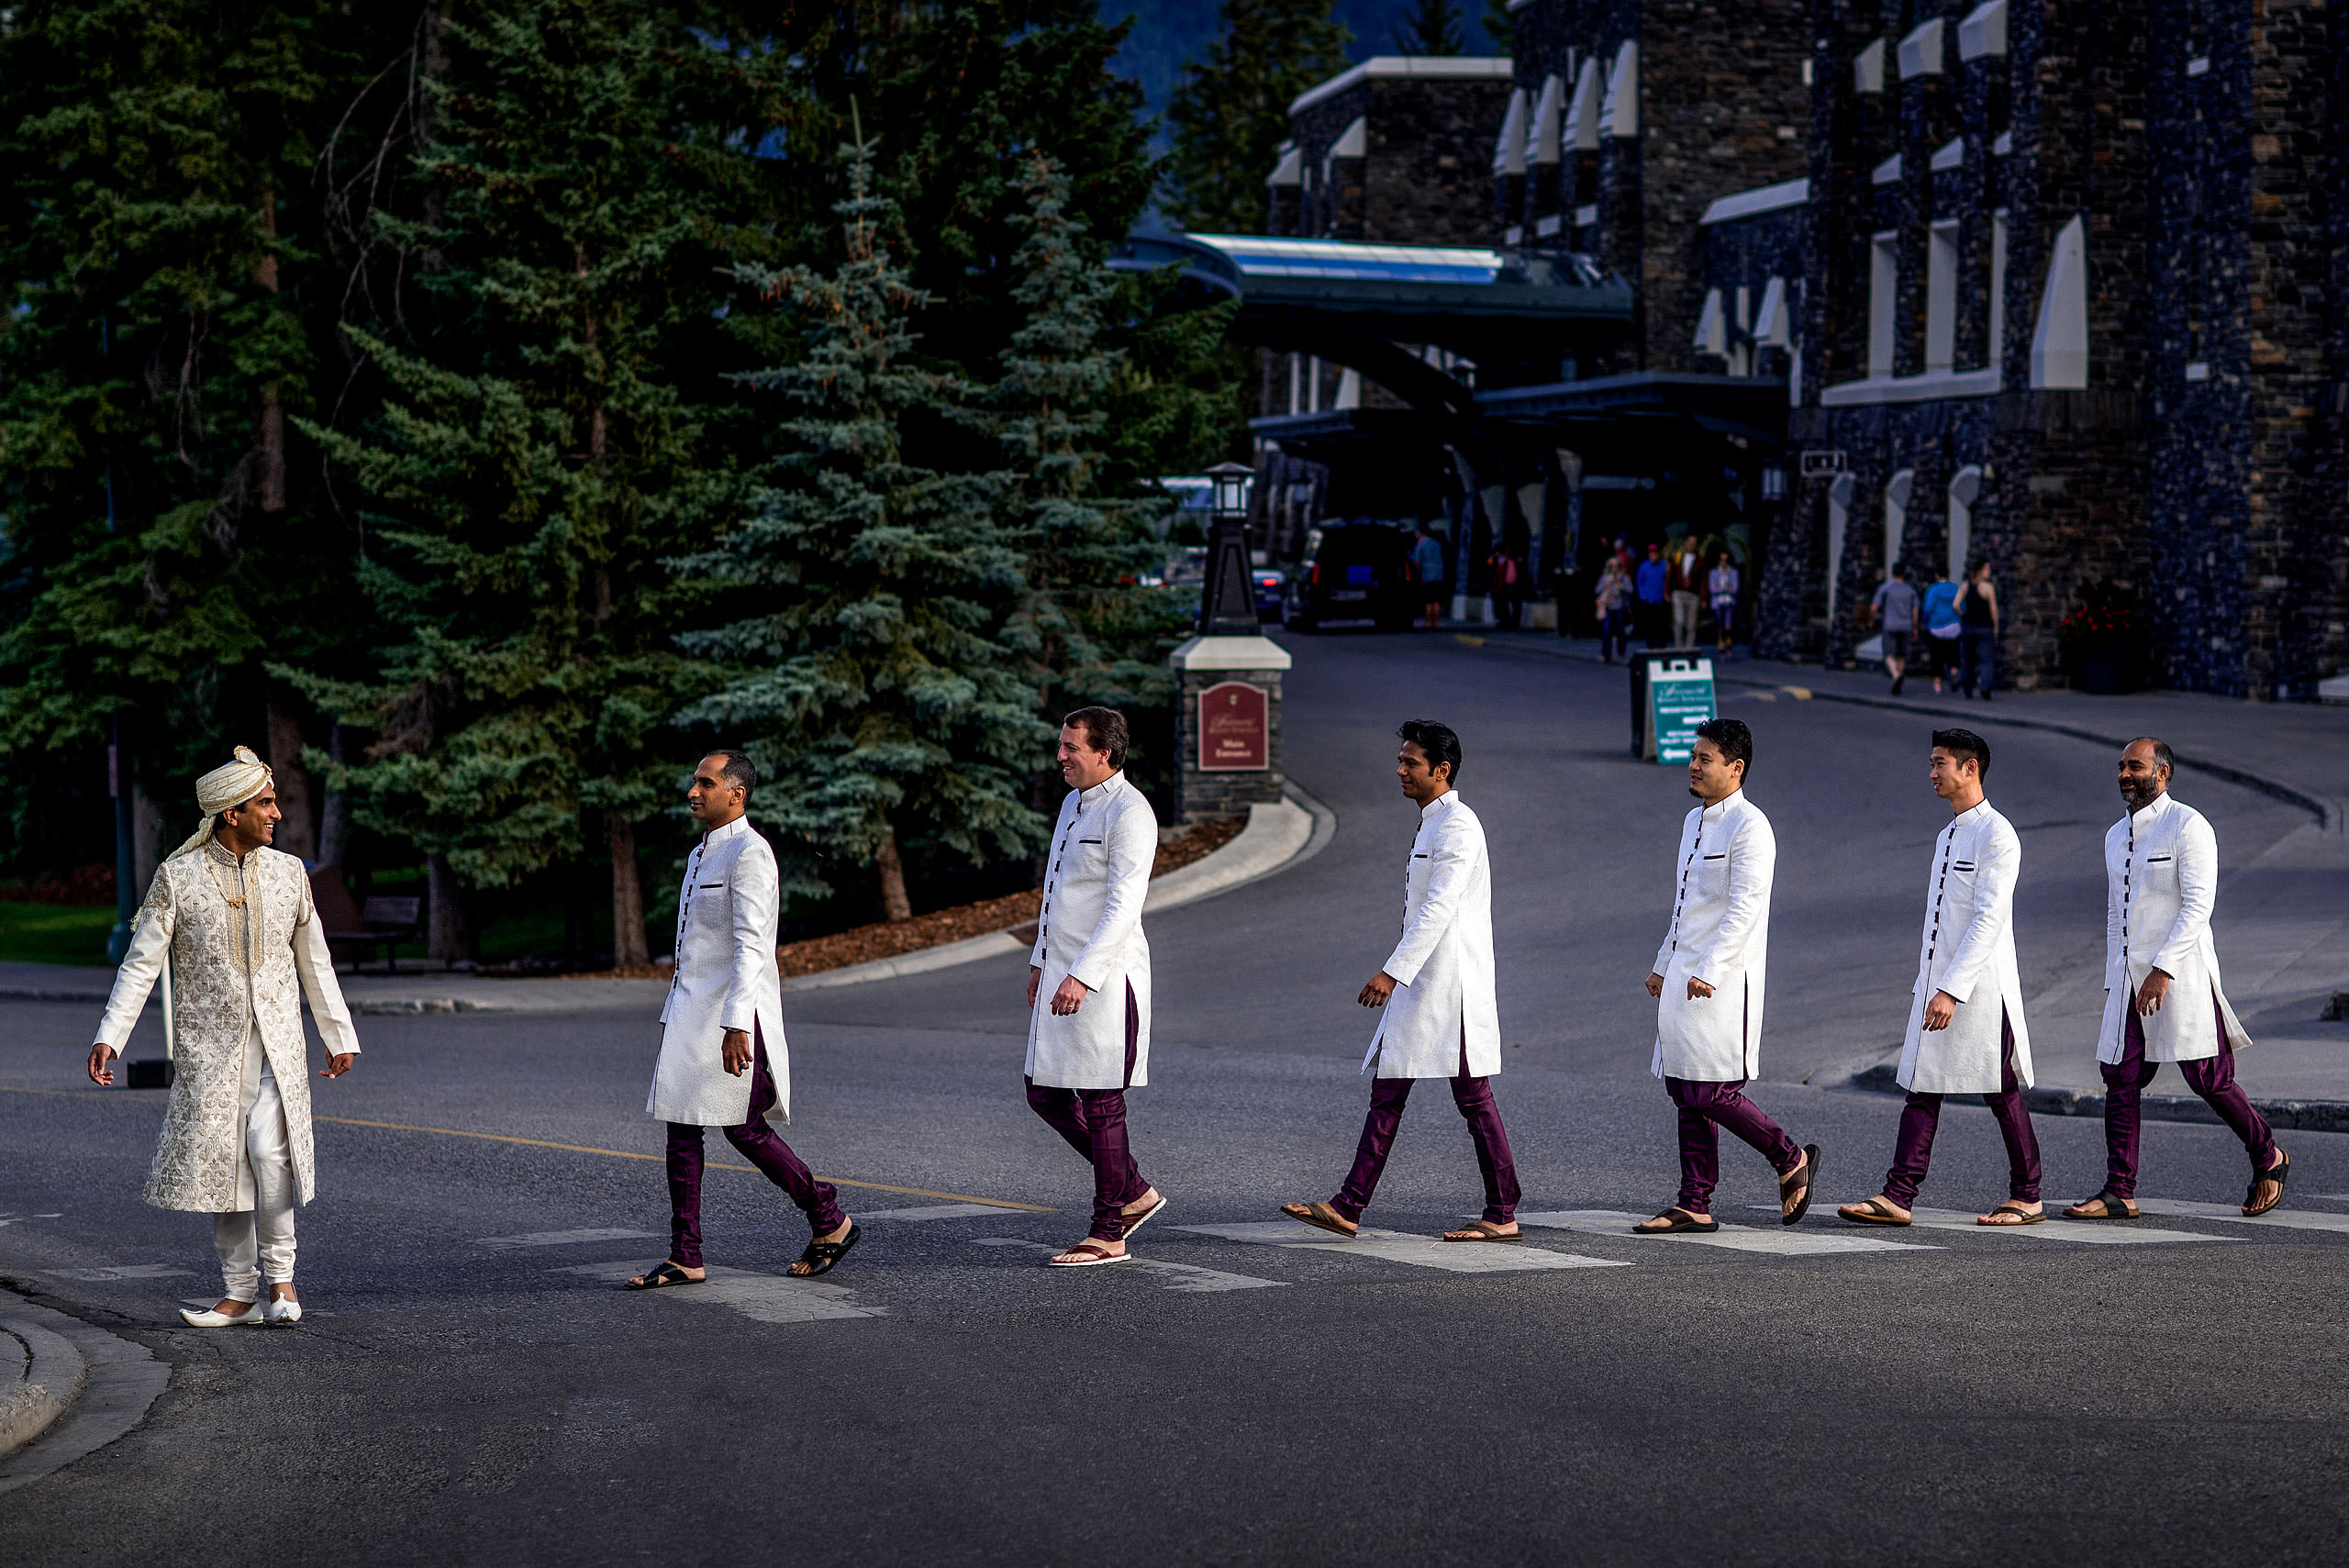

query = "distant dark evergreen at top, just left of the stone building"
[1165,0,1351,235]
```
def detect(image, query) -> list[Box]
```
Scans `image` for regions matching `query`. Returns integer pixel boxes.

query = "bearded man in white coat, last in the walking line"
[2065,735,2293,1220]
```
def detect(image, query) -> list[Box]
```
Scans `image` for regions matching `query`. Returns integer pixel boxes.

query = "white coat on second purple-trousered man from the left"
[1027,773,1158,1089]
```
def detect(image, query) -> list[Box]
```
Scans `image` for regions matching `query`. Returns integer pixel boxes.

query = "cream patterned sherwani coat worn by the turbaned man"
[99,842,360,1214]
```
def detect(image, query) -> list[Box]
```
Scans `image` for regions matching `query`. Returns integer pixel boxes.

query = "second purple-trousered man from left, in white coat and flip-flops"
[1027,706,1167,1268]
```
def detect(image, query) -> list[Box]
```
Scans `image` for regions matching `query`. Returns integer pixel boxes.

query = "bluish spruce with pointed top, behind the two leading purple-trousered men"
[681,136,1052,920]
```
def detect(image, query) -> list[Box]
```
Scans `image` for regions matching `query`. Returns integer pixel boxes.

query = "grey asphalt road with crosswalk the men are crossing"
[0,636,2349,1565]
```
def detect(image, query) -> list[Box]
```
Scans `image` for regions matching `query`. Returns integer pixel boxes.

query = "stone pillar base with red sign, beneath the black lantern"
[1167,636,1289,827]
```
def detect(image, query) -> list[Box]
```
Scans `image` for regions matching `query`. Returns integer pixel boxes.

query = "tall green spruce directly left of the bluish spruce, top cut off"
[280,0,765,967]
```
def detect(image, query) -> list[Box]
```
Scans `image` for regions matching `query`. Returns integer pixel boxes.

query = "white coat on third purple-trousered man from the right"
[1649,789,1778,1082]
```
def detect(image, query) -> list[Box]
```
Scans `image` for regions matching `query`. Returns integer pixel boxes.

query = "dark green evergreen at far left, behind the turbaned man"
[0,0,404,859]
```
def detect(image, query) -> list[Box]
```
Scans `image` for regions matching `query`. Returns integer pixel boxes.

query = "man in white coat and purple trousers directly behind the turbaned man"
[628,751,863,1291]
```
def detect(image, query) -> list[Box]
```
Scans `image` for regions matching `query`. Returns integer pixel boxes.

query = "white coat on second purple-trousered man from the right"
[1898,800,2032,1094]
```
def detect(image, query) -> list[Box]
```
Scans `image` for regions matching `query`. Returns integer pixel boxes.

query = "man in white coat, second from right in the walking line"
[1837,730,2046,1225]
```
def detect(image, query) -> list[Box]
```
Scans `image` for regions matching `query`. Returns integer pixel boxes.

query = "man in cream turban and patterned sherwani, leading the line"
[89,747,360,1329]
